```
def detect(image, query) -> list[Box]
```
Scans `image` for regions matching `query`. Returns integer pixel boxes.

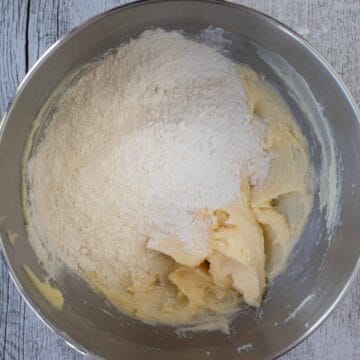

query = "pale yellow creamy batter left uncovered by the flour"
[78,67,312,328]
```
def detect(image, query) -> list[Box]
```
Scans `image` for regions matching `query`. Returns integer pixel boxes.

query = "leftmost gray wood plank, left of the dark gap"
[0,0,28,359]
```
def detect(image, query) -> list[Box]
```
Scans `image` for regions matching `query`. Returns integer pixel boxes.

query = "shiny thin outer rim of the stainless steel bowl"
[0,0,360,358]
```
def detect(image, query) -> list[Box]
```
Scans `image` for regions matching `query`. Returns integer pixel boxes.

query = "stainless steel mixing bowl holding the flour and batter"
[0,0,360,360]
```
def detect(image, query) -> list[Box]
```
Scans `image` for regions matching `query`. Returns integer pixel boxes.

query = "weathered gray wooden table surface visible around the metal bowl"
[0,0,360,360]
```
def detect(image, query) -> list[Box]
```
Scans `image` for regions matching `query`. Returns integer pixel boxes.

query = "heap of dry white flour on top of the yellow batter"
[29,30,270,284]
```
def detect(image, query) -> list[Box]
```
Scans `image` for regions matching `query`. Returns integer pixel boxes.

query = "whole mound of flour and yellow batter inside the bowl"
[24,29,312,325]
